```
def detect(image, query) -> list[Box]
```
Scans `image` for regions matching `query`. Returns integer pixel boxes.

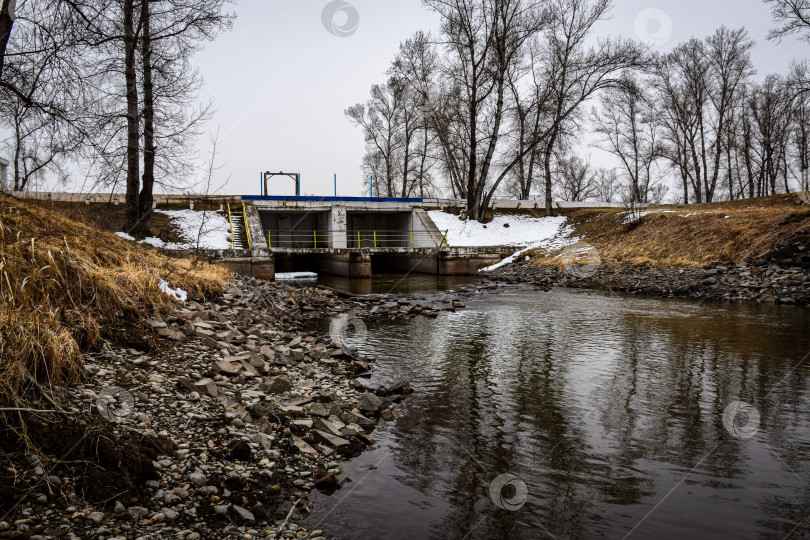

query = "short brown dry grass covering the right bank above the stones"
[537,195,810,266]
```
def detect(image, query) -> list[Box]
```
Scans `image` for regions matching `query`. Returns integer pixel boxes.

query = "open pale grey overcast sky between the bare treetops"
[189,0,810,196]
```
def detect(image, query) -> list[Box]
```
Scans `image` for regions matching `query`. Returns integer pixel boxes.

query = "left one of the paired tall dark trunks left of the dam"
[124,0,140,233]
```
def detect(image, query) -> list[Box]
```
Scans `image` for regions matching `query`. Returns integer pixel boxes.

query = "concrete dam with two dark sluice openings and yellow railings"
[211,196,514,279]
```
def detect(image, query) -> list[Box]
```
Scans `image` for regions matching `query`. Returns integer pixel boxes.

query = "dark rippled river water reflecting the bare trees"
[311,288,810,540]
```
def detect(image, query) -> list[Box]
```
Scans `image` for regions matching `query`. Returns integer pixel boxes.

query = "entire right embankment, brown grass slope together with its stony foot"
[491,195,810,305]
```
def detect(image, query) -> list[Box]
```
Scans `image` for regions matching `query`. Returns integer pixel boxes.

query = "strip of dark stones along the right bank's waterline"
[488,245,810,306]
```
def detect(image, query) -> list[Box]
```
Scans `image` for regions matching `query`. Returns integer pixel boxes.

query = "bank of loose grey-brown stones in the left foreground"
[0,279,474,539]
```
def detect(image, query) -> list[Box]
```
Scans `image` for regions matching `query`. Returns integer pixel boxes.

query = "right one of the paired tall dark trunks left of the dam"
[135,0,155,234]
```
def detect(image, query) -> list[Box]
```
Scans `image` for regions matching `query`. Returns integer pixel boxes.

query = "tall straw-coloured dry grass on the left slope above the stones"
[0,195,228,414]
